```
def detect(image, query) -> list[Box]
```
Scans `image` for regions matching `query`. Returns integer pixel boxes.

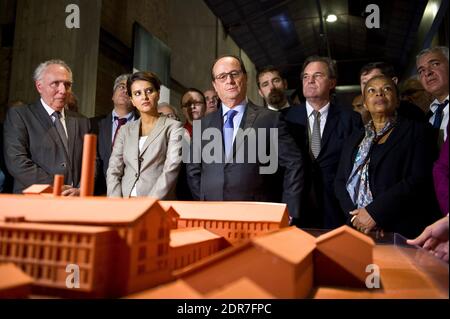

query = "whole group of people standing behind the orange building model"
[0,47,449,260]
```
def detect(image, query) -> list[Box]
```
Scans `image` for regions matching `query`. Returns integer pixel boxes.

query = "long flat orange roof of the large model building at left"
[0,195,163,225]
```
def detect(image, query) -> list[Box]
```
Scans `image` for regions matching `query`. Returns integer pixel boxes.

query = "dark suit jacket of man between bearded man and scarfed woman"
[284,103,362,229]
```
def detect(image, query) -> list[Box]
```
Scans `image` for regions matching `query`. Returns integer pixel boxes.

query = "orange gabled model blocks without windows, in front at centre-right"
[130,226,374,298]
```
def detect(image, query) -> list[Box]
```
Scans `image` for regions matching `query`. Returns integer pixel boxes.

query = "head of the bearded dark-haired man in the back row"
[256,66,290,112]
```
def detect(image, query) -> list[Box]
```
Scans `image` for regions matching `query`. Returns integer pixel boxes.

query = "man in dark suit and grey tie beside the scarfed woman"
[286,56,362,229]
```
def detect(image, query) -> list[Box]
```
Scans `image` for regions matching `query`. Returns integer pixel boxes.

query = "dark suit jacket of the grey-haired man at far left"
[4,101,90,193]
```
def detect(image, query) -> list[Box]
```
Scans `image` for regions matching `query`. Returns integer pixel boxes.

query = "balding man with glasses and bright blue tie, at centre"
[186,55,303,221]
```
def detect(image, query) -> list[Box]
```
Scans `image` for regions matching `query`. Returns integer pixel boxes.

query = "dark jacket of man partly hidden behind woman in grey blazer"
[89,111,139,195]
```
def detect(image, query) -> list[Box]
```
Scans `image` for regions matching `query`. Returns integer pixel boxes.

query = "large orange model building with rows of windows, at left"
[0,196,287,297]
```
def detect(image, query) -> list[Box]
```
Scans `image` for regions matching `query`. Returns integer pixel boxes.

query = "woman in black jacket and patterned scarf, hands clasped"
[335,76,439,237]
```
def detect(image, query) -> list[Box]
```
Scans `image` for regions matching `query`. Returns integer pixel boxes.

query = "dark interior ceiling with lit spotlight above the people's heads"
[205,0,427,89]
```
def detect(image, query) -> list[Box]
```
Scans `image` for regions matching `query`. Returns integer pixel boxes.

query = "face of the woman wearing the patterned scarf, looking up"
[364,78,398,116]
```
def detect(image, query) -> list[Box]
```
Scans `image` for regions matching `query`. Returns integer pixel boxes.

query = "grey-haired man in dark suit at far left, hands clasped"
[4,60,90,196]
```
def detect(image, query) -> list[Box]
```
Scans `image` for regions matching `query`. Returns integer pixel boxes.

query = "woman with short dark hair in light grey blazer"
[106,72,184,199]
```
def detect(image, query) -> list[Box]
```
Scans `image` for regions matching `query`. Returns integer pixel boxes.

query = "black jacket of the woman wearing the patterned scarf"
[335,116,439,238]
